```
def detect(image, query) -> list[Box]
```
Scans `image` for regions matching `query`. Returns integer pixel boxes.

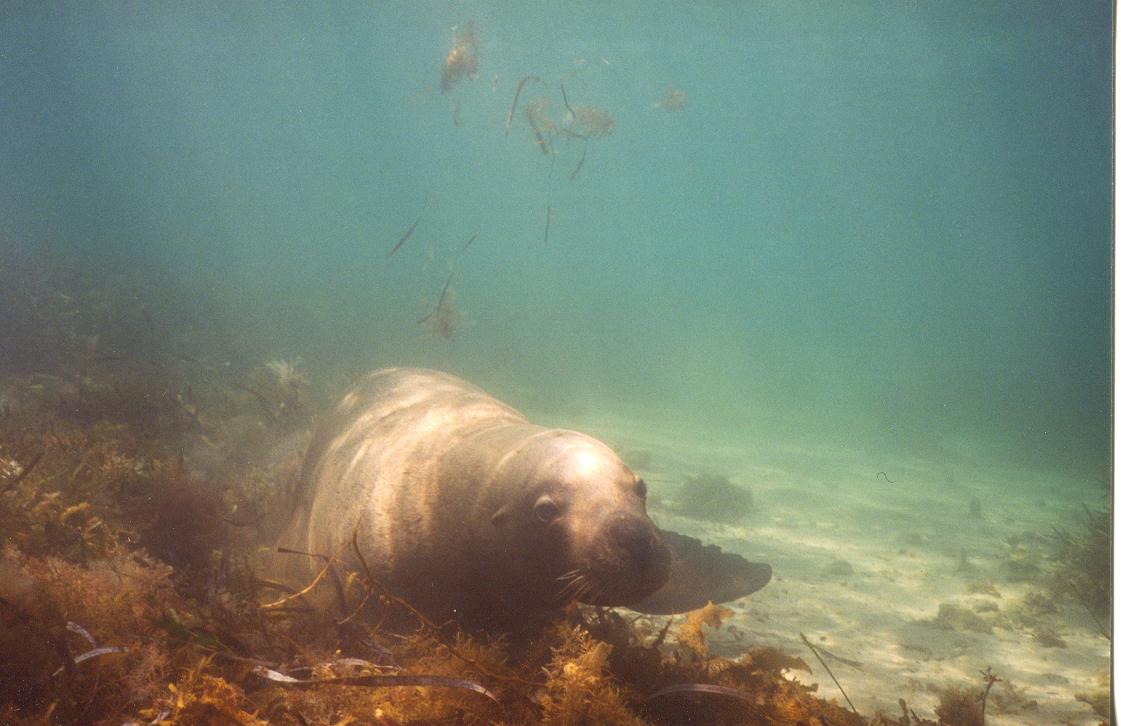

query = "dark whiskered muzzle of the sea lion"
[557,516,671,607]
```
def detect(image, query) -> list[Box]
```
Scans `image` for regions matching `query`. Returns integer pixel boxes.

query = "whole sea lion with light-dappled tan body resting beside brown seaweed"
[273,369,770,625]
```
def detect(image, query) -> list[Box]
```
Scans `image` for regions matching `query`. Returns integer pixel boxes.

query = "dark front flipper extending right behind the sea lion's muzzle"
[628,530,771,615]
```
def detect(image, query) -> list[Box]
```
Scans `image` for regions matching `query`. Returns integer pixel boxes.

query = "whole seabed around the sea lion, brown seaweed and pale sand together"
[0,351,1110,726]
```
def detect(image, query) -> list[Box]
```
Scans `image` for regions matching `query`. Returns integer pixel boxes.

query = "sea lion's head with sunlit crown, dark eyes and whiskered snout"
[491,429,671,606]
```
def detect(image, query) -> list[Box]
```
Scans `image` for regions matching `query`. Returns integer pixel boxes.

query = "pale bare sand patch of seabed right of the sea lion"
[568,418,1110,725]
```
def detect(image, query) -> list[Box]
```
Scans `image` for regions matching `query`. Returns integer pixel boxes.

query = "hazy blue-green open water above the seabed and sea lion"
[0,0,1113,481]
